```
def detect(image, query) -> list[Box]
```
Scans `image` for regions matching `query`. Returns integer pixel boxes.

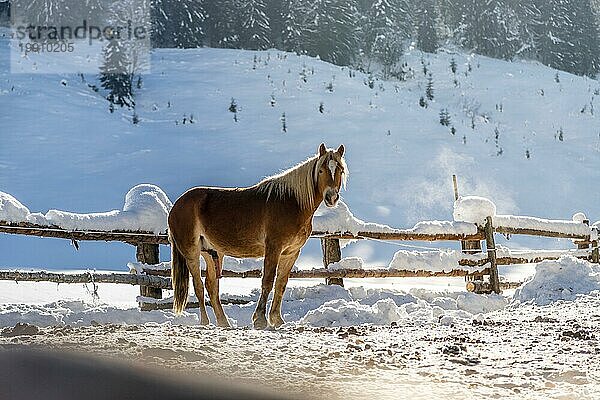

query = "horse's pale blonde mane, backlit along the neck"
[256,151,348,209]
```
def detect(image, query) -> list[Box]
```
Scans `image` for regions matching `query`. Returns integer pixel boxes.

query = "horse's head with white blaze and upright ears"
[314,143,348,207]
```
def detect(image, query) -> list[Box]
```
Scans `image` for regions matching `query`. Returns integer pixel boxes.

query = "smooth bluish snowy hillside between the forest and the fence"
[0,31,600,269]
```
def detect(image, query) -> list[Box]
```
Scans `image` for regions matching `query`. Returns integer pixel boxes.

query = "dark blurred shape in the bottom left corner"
[0,346,287,400]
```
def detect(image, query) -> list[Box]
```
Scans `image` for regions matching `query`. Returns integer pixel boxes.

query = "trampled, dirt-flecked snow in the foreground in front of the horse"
[0,286,600,400]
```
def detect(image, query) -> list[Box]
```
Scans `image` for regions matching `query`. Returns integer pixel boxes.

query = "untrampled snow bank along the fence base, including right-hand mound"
[0,256,600,327]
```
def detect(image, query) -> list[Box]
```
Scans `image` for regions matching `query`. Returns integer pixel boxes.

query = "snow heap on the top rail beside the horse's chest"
[312,201,397,235]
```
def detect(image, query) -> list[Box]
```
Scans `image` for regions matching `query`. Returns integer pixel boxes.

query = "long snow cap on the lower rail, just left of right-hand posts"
[389,250,485,272]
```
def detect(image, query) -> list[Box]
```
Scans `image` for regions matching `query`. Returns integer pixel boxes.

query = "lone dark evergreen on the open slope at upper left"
[100,40,135,107]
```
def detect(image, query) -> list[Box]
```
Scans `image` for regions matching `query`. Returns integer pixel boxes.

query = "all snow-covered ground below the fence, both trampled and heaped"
[0,257,600,400]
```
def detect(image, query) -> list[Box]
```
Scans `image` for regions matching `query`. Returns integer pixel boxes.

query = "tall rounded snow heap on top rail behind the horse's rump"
[46,184,173,233]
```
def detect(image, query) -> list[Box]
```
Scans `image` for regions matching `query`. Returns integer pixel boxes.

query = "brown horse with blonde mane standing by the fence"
[169,143,348,329]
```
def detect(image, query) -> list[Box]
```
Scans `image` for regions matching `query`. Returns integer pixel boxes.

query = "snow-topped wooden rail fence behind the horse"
[0,209,600,309]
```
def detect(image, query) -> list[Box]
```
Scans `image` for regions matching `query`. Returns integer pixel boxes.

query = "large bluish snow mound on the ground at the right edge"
[513,256,600,305]
